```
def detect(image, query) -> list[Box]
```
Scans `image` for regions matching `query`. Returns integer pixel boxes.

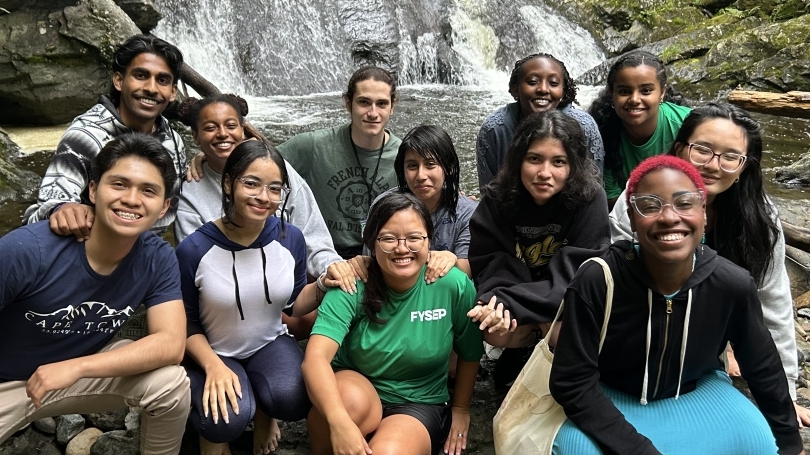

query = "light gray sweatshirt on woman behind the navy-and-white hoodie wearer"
[174,161,342,277]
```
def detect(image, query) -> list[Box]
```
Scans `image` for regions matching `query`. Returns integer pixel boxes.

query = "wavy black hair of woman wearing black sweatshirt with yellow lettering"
[482,109,601,219]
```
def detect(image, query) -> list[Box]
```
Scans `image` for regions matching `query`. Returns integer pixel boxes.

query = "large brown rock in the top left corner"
[0,0,140,125]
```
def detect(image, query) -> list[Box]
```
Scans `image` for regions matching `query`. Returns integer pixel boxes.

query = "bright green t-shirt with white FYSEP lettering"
[312,267,484,404]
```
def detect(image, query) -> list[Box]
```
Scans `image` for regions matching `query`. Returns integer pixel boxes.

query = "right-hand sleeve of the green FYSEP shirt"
[442,268,484,362]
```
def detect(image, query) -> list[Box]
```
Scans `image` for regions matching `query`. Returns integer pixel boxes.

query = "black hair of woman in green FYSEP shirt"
[362,191,433,324]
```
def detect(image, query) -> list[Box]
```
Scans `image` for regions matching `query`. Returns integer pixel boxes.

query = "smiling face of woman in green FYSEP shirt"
[374,208,430,294]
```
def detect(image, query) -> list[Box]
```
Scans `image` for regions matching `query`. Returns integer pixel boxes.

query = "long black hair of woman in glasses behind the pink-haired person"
[669,103,779,285]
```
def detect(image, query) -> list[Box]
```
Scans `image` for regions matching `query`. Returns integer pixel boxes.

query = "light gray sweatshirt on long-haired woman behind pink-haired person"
[610,190,799,401]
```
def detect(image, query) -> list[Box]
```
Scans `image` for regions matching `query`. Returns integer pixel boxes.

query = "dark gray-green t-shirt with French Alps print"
[278,124,401,257]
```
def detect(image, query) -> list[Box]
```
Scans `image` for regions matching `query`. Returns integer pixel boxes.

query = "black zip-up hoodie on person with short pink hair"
[550,241,802,455]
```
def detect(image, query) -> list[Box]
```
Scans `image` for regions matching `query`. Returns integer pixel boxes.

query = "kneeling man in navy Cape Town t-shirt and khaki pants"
[0,133,190,455]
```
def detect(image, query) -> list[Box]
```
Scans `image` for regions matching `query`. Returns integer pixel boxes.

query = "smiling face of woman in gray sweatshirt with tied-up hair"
[191,103,245,174]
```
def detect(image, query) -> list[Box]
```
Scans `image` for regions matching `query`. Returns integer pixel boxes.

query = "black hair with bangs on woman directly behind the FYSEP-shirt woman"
[394,125,460,220]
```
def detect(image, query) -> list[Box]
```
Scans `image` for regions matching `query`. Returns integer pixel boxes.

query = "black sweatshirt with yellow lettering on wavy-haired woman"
[469,189,610,325]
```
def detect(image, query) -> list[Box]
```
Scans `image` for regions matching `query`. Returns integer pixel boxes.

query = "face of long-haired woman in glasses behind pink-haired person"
[675,118,748,203]
